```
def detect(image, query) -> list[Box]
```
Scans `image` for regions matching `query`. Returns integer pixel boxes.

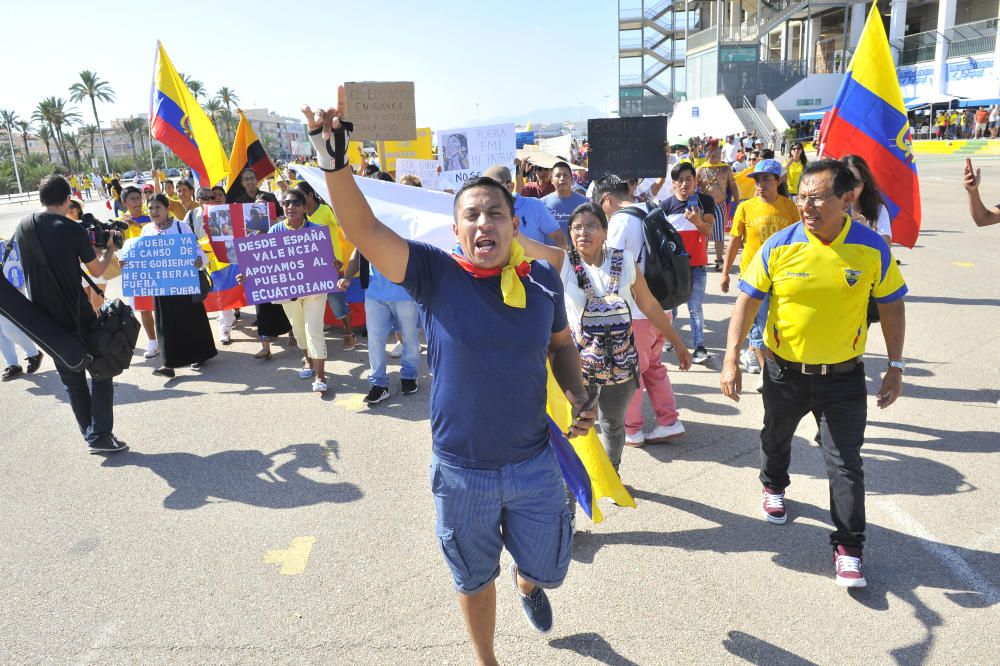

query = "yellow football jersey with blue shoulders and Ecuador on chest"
[740,216,907,364]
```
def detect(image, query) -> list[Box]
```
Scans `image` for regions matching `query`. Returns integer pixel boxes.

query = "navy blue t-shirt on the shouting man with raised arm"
[403,241,567,469]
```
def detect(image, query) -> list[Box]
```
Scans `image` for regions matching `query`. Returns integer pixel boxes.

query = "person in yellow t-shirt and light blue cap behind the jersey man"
[720,160,802,384]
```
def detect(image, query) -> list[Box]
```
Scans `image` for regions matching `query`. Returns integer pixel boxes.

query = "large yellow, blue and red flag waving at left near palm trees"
[149,42,229,186]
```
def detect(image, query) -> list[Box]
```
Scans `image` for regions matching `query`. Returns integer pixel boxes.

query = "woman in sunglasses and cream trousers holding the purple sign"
[268,188,327,393]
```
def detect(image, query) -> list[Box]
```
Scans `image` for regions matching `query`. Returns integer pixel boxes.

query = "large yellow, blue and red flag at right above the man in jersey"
[819,2,920,247]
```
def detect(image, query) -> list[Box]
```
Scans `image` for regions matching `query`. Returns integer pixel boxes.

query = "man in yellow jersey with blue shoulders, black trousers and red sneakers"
[721,160,906,587]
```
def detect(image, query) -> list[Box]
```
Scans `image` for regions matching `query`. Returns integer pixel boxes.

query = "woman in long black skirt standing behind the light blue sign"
[138,194,218,377]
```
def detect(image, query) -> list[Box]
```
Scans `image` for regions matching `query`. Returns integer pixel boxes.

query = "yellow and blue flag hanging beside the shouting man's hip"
[546,368,635,523]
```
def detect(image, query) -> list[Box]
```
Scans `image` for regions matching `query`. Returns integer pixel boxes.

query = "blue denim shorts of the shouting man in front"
[430,446,573,594]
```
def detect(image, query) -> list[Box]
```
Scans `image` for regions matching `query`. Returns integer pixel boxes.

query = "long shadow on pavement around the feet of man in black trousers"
[573,490,1000,664]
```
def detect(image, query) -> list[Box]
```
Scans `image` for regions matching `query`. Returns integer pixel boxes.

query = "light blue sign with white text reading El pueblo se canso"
[120,234,199,296]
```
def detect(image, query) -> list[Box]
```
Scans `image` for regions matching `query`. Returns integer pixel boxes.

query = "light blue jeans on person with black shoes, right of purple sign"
[365,296,420,388]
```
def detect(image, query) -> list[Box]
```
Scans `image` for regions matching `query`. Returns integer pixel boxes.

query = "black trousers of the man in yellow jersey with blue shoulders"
[760,359,868,548]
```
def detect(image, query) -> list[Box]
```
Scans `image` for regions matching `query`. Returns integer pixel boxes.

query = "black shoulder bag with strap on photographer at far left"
[25,216,140,379]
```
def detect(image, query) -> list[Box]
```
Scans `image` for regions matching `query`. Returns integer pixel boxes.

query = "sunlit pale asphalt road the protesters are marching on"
[0,154,1000,664]
